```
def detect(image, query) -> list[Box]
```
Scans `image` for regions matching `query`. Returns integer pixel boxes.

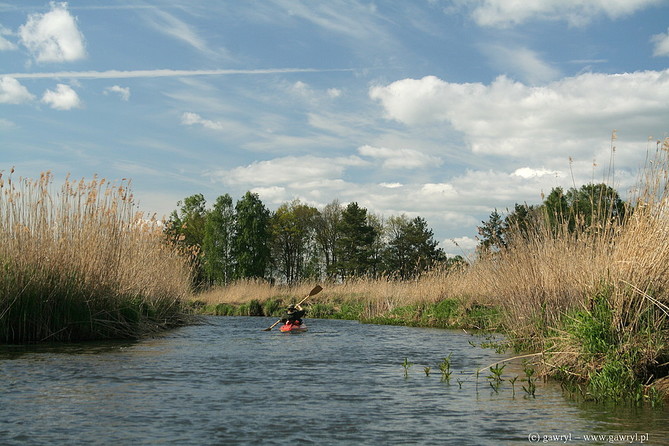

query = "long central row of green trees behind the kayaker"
[165,192,463,286]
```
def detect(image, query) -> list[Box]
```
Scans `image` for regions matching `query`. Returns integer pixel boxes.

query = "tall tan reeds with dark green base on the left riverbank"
[0,173,190,343]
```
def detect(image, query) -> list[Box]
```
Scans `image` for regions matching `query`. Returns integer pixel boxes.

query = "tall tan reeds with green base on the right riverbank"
[446,139,669,398]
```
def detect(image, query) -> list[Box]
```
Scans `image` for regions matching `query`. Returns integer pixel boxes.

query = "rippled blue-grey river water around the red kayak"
[0,317,669,446]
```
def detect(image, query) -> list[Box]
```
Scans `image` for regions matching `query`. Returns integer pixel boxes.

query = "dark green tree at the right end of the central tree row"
[384,215,446,280]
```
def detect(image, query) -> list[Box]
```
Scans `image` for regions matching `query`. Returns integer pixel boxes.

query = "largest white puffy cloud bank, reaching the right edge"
[369,70,669,157]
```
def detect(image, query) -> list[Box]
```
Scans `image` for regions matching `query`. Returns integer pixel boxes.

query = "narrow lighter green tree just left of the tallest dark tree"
[202,194,235,285]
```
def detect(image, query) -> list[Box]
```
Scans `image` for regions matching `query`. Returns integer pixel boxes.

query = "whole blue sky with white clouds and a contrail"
[0,0,669,255]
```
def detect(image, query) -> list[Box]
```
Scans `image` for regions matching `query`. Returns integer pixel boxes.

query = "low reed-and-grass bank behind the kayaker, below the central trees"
[192,276,501,331]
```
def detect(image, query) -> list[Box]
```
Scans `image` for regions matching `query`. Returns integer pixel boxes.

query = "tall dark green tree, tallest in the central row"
[232,192,270,278]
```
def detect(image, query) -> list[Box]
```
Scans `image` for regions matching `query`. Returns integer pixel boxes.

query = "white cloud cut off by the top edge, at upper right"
[459,0,662,27]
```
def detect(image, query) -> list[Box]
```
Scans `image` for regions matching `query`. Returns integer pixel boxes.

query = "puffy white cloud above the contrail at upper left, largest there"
[19,2,86,62]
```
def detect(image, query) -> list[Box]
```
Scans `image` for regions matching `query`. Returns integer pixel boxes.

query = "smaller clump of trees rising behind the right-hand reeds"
[478,183,631,252]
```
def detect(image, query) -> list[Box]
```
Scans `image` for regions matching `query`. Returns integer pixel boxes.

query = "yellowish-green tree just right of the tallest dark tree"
[271,200,319,284]
